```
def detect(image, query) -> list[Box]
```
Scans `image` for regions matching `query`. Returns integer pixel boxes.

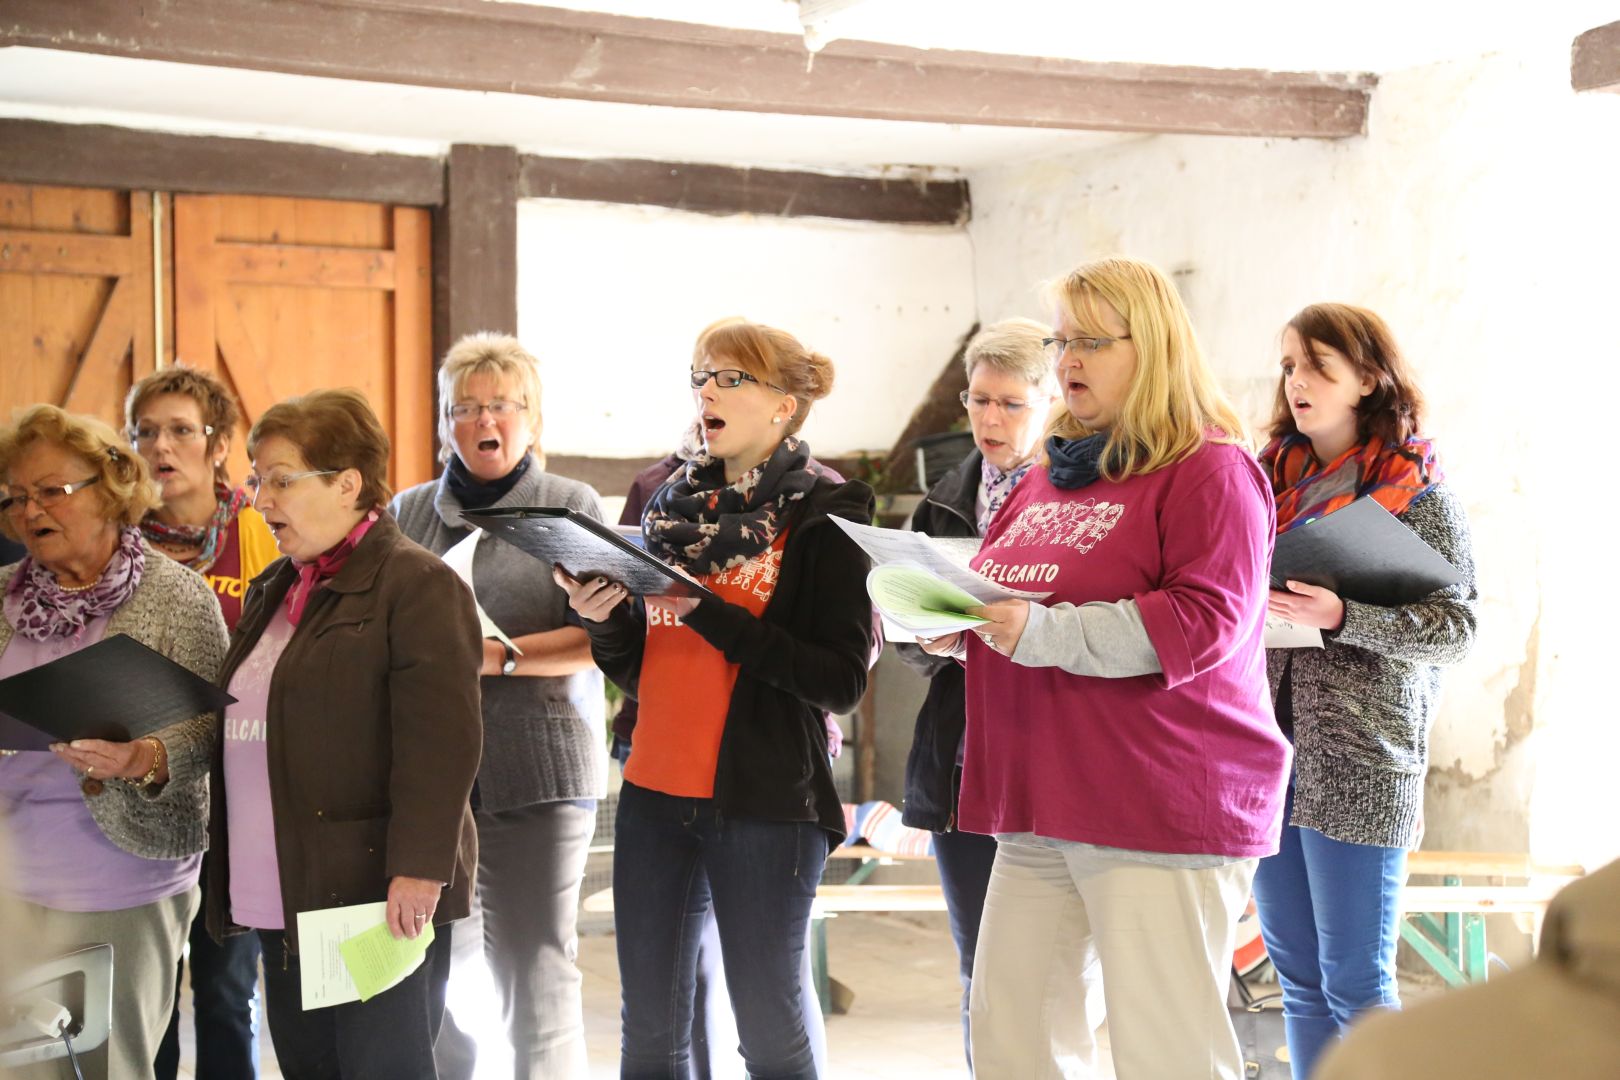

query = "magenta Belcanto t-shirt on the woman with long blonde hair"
[959,444,1291,858]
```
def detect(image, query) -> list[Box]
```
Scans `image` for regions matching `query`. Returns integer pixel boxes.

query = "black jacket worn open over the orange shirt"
[585,478,873,840]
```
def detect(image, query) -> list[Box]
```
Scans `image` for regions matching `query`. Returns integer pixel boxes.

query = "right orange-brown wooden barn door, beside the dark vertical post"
[173,196,433,489]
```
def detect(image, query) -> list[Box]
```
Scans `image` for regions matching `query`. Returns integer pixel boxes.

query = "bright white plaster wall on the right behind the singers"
[969,39,1620,865]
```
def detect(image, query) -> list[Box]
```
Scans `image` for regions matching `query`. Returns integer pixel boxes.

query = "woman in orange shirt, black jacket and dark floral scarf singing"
[556,319,872,1080]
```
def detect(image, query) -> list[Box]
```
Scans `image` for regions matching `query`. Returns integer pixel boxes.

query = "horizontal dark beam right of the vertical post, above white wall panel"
[518,155,969,225]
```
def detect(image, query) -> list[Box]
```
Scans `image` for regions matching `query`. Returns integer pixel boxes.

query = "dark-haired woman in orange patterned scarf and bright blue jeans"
[1254,304,1479,1080]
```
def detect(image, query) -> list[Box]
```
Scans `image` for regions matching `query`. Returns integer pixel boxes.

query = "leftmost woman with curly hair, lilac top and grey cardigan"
[0,405,225,1080]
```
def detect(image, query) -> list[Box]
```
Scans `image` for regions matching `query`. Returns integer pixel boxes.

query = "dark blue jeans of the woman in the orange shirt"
[612,782,828,1080]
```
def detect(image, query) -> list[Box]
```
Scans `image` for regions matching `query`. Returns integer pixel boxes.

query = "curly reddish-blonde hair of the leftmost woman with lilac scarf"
[0,405,162,539]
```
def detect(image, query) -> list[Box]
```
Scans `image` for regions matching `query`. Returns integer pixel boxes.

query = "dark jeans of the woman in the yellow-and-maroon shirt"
[152,886,259,1080]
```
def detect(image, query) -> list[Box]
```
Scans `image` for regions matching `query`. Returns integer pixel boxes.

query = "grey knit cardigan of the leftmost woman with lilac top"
[0,541,227,858]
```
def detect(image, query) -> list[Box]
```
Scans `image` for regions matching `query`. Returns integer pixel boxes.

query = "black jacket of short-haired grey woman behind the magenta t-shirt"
[894,450,983,832]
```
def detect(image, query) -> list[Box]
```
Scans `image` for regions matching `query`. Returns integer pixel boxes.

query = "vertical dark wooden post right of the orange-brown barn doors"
[433,146,518,367]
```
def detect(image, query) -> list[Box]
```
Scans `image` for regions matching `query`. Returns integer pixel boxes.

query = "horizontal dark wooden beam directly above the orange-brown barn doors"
[0,120,444,206]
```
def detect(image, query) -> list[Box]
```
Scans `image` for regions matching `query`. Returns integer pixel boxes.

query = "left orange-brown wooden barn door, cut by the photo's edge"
[0,185,162,429]
